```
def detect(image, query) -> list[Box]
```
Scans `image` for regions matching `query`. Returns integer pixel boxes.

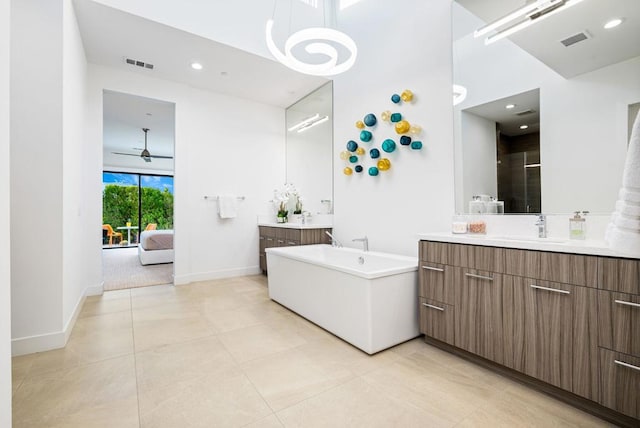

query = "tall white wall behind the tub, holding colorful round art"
[334,0,454,255]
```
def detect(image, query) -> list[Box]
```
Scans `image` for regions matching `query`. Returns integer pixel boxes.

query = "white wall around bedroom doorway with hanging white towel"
[87,65,285,284]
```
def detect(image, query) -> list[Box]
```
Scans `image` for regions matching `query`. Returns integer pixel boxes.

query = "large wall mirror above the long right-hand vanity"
[452,0,640,213]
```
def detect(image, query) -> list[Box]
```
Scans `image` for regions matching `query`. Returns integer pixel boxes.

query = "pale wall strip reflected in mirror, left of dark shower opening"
[461,112,498,206]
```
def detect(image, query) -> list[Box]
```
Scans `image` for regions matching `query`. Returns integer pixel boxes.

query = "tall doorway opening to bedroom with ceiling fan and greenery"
[102,90,175,291]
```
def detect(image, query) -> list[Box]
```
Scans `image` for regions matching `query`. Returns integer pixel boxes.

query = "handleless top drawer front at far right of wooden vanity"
[598,257,640,294]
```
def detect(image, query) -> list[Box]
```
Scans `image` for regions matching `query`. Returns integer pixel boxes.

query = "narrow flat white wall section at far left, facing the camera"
[10,0,64,351]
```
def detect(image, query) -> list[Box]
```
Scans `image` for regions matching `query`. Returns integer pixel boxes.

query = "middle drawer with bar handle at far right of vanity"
[598,290,640,358]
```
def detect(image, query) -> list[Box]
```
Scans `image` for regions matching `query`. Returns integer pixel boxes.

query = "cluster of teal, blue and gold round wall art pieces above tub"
[340,89,422,177]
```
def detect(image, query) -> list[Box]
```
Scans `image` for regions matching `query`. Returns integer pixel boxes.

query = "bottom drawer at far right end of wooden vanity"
[600,348,640,419]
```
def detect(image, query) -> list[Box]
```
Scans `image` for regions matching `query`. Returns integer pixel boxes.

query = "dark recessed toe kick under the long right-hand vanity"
[424,336,638,428]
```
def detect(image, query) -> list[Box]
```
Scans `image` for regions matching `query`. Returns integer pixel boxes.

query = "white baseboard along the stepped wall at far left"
[11,283,103,357]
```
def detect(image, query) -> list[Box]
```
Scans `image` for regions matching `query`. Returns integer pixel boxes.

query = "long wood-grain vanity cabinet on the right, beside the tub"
[419,241,628,418]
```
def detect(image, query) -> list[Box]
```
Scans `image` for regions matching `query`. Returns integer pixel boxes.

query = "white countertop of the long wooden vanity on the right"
[418,232,640,259]
